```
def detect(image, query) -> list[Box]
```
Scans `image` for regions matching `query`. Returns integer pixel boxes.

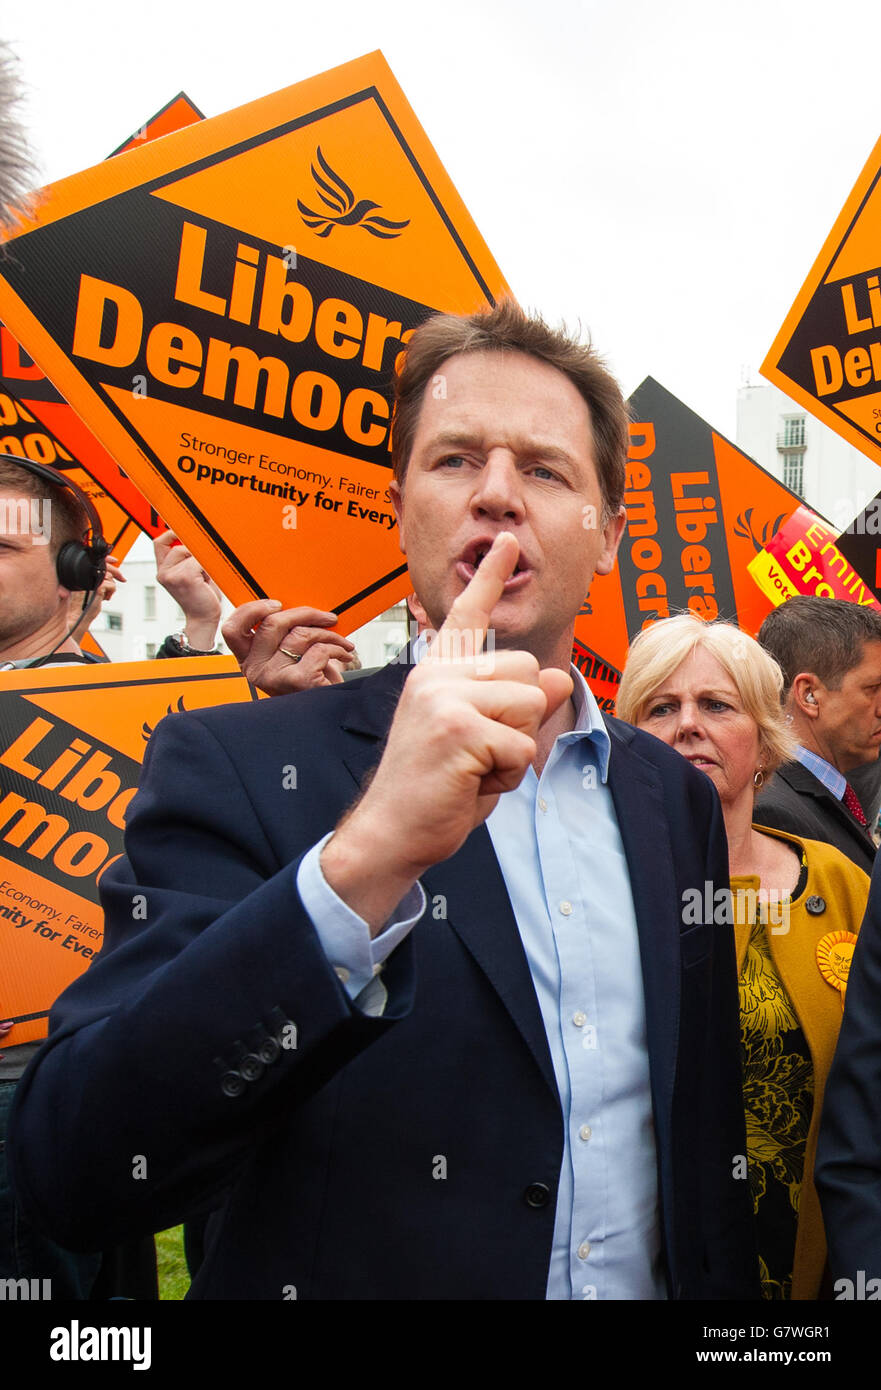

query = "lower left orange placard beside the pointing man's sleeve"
[0,656,257,1047]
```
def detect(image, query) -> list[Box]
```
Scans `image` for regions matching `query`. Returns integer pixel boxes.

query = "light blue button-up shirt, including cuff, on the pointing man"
[297,656,666,1300]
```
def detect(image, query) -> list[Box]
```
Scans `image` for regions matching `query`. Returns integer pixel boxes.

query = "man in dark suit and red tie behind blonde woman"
[755,596,881,874]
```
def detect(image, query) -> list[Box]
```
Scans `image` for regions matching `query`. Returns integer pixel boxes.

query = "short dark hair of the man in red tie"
[759,594,881,694]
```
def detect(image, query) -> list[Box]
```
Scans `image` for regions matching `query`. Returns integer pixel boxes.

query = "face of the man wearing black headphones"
[0,489,68,652]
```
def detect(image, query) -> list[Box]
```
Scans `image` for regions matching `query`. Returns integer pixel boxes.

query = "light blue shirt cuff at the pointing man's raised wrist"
[296,831,427,1001]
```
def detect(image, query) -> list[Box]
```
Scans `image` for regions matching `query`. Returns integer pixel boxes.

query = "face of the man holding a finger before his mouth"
[392,352,624,664]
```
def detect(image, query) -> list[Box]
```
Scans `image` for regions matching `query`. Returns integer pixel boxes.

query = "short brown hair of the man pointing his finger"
[392,299,629,518]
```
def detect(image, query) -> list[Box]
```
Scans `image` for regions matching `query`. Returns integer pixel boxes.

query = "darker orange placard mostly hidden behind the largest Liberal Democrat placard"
[0,92,203,542]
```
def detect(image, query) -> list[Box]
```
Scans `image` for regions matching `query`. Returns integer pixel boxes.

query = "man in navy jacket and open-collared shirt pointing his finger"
[13,306,756,1298]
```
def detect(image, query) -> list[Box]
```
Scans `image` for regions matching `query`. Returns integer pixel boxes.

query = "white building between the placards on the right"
[736,381,881,531]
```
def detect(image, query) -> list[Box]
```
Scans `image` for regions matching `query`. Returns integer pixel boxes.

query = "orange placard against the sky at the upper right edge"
[761,130,881,463]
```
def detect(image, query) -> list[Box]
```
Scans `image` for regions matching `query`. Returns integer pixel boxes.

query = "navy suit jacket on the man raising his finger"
[11,666,756,1298]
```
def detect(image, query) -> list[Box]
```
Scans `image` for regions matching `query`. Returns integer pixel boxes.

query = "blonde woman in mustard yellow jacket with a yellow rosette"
[617,614,868,1298]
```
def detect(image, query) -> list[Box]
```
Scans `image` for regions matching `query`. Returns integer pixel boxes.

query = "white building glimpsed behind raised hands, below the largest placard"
[92,535,409,667]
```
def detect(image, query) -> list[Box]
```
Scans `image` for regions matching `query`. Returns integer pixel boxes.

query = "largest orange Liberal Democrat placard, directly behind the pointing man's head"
[0,53,509,632]
